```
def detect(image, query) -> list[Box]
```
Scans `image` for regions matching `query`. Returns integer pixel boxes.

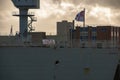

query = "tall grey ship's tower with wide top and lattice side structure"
[12,0,39,39]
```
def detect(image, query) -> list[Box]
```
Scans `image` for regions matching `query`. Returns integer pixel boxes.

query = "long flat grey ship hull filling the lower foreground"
[0,47,119,80]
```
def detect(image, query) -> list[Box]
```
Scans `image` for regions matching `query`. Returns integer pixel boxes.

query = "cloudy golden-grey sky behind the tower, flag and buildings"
[0,0,120,35]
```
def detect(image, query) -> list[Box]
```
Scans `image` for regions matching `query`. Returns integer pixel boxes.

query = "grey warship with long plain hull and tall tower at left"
[0,0,120,80]
